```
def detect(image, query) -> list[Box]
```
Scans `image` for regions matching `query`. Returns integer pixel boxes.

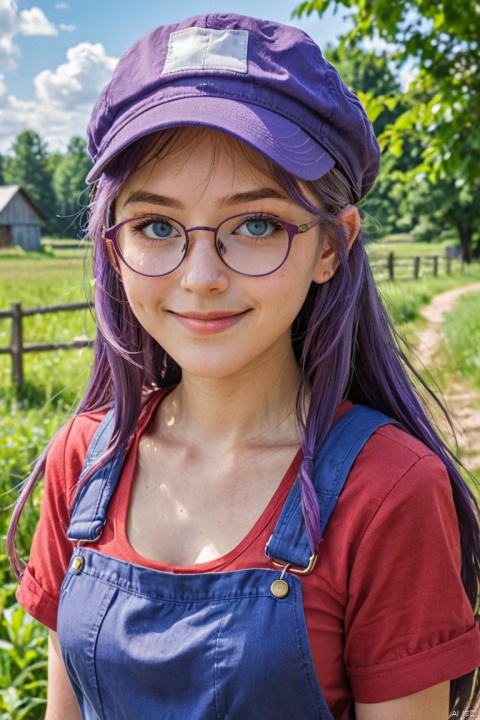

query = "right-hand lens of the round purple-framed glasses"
[217,214,289,275]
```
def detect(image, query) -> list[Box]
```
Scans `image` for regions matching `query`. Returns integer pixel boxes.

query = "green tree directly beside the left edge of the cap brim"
[50,137,92,235]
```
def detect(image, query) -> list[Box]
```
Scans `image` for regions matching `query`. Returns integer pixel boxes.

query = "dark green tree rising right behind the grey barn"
[4,130,56,232]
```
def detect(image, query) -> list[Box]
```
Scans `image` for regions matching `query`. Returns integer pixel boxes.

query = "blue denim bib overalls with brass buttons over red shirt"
[58,406,391,720]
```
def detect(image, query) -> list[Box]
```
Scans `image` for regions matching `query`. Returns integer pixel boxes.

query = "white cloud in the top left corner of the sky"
[0,0,58,70]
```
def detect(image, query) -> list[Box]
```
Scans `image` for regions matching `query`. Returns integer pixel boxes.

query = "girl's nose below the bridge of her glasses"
[180,228,229,295]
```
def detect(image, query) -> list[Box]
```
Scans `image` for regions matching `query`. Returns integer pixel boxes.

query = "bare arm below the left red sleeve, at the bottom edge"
[45,630,81,720]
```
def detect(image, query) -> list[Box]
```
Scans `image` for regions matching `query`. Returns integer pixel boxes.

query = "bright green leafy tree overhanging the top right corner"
[295,0,480,260]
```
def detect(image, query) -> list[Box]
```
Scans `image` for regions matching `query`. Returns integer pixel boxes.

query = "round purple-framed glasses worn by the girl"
[103,213,321,277]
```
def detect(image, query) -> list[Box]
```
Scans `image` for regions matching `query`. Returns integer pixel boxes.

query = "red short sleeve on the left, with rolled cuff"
[17,414,100,630]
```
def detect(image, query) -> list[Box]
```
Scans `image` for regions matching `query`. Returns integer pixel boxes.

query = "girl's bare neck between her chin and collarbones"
[159,353,301,450]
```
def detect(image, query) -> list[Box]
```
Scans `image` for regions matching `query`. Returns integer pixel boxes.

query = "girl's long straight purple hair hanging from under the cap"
[7,130,480,714]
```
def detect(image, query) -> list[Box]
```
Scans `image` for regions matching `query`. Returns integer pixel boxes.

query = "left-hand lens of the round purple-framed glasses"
[117,216,187,276]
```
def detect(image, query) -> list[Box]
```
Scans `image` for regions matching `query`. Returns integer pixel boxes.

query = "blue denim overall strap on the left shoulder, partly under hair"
[67,408,125,542]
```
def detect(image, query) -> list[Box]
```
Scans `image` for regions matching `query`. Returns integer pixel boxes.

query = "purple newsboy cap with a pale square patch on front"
[87,13,380,200]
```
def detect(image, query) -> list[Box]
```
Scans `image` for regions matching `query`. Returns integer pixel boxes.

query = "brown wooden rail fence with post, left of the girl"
[0,302,93,396]
